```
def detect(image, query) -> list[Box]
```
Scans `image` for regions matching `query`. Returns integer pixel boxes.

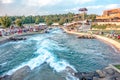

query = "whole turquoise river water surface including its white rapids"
[0,28,120,80]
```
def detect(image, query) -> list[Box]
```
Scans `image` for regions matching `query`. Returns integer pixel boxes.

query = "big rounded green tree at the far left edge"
[0,16,11,28]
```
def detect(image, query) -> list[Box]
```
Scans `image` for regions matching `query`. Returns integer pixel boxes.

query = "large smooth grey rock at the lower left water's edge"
[11,66,31,80]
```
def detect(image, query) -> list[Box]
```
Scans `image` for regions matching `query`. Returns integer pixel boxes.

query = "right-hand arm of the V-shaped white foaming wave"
[35,49,74,72]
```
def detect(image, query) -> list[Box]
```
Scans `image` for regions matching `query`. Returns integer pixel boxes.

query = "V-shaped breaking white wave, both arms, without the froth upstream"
[7,45,73,75]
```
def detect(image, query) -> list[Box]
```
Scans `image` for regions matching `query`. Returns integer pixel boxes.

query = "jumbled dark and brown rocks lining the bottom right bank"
[75,67,120,80]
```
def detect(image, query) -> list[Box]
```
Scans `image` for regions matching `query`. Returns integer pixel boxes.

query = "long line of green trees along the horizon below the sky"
[0,12,97,27]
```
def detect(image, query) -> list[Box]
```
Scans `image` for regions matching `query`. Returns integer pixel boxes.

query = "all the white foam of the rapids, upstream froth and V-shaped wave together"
[4,30,75,79]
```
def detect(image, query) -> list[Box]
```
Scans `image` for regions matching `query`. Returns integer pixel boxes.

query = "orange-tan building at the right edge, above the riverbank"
[95,8,120,25]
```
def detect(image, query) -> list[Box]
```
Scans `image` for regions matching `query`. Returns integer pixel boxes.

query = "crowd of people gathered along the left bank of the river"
[0,26,46,36]
